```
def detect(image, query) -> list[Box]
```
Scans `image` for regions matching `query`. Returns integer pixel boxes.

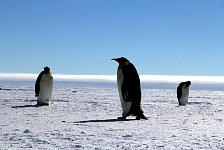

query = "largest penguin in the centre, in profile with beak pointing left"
[111,57,147,120]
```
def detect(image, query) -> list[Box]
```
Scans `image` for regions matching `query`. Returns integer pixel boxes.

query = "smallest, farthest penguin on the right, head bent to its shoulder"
[177,81,191,106]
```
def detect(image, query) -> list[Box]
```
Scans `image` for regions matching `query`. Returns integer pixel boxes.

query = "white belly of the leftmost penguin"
[37,74,53,104]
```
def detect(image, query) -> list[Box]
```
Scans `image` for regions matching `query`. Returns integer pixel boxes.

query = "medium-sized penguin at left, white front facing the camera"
[35,67,53,105]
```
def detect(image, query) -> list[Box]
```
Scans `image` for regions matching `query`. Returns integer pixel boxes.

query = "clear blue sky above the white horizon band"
[0,0,224,75]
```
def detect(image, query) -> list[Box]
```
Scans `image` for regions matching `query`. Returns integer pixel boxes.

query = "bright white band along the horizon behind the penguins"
[0,73,224,84]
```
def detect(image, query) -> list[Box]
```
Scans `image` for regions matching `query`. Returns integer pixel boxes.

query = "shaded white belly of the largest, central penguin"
[117,66,132,117]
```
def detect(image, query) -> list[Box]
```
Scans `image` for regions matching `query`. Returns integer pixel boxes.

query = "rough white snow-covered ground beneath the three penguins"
[0,80,224,150]
